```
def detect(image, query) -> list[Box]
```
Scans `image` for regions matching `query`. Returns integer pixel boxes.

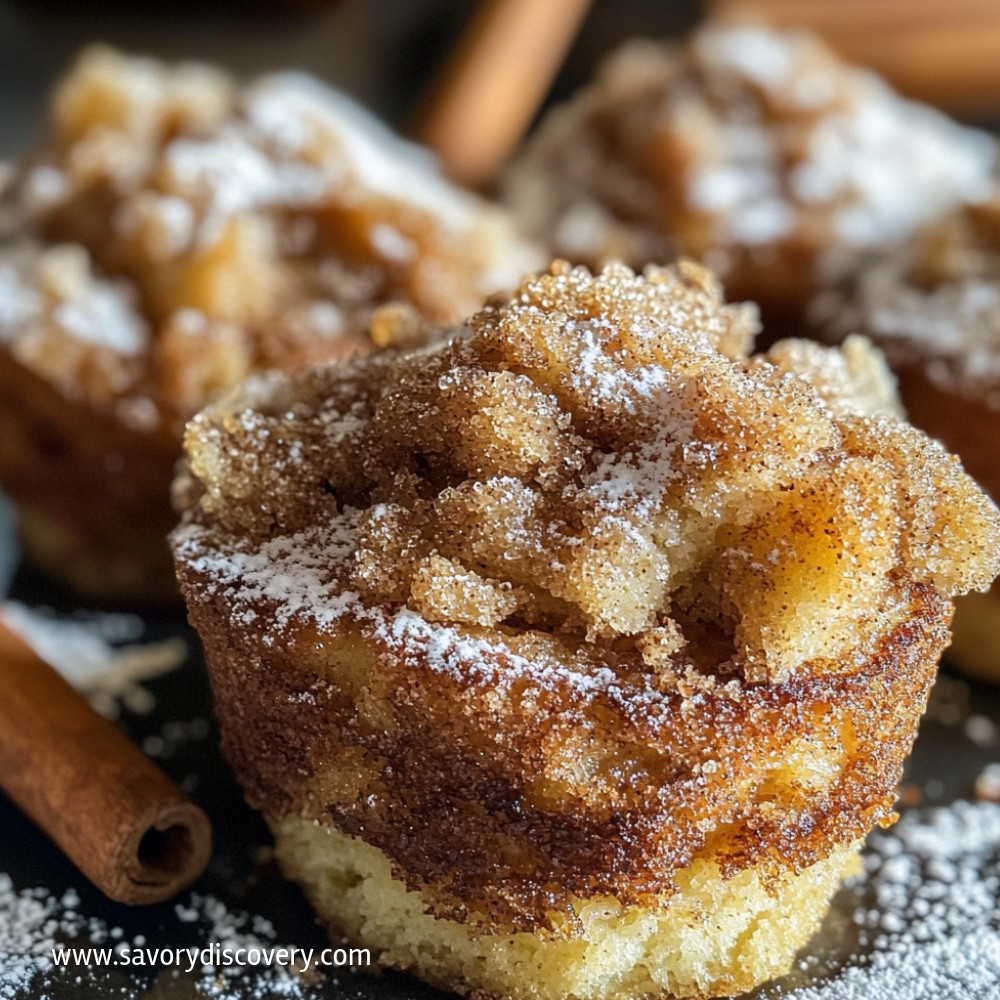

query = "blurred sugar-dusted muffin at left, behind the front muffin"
[0,48,540,601]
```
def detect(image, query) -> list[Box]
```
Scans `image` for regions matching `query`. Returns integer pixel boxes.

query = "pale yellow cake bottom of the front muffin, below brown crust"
[272,817,860,1000]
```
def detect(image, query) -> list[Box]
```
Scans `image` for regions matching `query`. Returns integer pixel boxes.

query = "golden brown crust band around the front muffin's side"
[179,560,950,933]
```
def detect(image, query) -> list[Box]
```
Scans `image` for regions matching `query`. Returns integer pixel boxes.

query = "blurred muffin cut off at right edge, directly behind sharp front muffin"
[812,194,1000,682]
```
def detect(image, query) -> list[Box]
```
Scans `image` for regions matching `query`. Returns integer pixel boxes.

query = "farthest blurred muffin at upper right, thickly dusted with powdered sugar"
[505,21,996,333]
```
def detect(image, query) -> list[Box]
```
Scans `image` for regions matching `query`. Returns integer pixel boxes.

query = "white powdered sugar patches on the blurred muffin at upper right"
[691,26,996,256]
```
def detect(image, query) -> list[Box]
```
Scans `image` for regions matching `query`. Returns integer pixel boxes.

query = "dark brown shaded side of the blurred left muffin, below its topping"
[0,348,180,606]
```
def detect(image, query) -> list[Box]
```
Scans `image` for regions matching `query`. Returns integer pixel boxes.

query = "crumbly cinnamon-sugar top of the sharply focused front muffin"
[174,263,1000,697]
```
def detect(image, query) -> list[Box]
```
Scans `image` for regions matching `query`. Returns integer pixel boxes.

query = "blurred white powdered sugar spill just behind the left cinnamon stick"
[0,601,187,718]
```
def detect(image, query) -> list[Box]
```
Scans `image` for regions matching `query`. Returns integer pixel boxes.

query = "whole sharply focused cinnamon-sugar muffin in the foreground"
[172,263,1000,1000]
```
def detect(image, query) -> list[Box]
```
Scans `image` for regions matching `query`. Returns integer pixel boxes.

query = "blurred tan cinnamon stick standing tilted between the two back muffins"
[416,0,590,185]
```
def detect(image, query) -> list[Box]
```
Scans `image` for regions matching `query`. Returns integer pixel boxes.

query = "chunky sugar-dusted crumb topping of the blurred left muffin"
[0,48,538,426]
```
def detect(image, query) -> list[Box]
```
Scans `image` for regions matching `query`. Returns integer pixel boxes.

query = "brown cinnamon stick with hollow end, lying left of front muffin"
[0,618,212,904]
